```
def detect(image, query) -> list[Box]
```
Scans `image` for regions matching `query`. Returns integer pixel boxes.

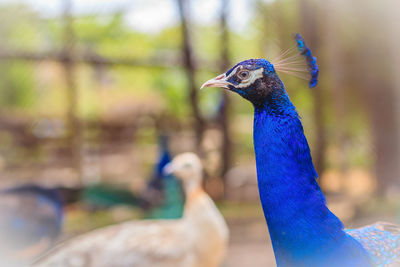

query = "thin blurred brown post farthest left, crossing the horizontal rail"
[62,0,83,183]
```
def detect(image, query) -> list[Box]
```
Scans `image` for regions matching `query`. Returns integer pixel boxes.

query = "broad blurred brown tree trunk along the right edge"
[353,1,400,196]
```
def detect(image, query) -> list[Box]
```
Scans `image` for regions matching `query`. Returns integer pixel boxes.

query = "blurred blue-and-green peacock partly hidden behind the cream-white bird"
[81,134,184,219]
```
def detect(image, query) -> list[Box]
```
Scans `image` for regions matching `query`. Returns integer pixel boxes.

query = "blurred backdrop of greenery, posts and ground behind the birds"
[0,0,400,267]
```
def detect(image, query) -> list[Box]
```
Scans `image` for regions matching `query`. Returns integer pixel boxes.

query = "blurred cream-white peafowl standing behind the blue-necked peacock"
[34,153,229,267]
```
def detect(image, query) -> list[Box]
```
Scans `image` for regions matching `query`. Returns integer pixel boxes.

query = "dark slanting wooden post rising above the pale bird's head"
[177,0,205,152]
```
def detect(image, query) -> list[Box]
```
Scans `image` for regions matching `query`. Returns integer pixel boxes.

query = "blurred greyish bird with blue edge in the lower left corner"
[0,184,64,266]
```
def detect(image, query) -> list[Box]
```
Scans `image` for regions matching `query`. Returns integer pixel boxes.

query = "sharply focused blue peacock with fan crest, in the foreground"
[202,34,400,267]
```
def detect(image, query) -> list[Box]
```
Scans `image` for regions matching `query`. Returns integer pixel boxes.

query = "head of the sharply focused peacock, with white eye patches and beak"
[201,59,285,106]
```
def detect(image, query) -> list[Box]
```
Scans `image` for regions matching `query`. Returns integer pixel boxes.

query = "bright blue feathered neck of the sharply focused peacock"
[254,82,370,267]
